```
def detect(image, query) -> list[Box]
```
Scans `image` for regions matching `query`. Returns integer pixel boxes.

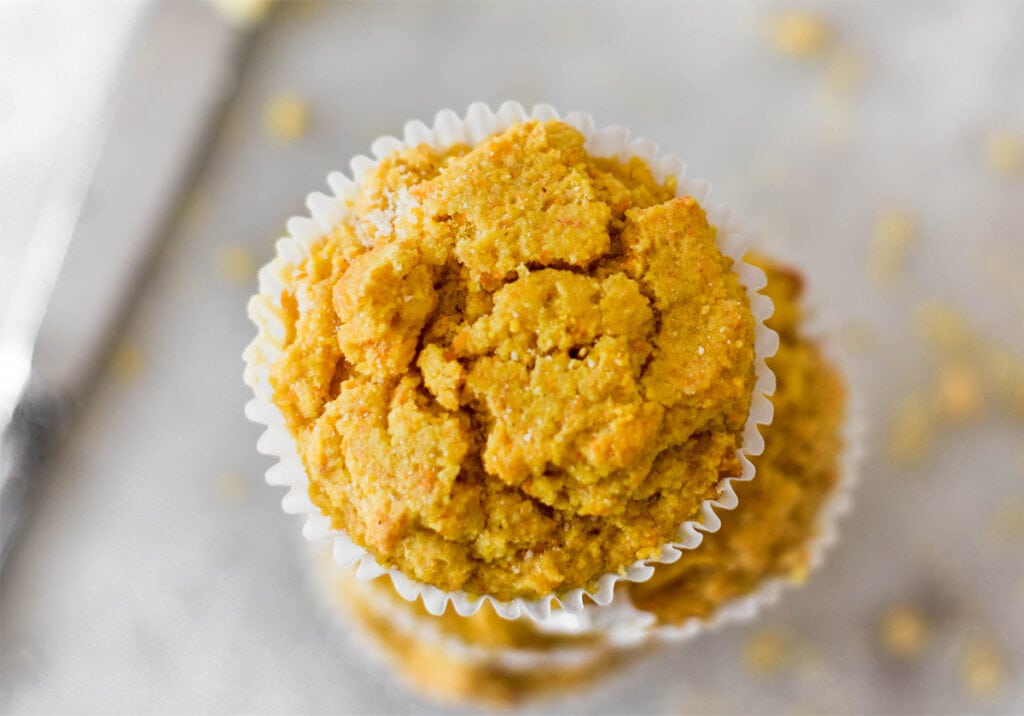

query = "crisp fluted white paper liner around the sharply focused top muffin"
[244,101,778,621]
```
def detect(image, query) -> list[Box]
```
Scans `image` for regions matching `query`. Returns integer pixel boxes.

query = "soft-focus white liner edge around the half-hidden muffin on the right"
[524,248,866,647]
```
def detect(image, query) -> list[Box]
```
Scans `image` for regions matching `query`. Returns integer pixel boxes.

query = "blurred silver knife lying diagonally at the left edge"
[0,0,260,568]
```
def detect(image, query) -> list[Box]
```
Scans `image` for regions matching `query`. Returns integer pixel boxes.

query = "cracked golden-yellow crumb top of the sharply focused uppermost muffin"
[270,121,755,600]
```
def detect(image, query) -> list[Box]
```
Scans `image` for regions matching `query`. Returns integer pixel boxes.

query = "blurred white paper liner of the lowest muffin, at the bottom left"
[309,542,610,673]
